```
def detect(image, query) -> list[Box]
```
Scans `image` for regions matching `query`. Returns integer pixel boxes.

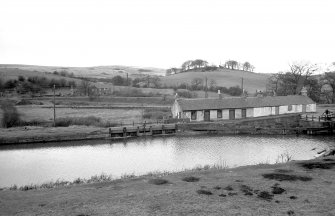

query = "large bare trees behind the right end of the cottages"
[267,62,335,103]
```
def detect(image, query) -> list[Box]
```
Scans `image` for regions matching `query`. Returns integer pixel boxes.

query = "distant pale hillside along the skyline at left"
[0,64,165,78]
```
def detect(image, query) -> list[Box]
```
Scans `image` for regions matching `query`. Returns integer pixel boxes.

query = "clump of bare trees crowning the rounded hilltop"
[165,59,255,76]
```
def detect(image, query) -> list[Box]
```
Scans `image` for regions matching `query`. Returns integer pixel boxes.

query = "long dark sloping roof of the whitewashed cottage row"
[177,95,315,111]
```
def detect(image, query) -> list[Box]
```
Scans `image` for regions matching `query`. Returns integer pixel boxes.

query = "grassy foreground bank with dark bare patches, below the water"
[0,157,335,216]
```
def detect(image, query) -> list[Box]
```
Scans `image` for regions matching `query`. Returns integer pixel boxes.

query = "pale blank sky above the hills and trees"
[0,0,335,73]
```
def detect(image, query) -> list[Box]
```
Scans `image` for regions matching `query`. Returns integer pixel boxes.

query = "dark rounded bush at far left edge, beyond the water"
[1,101,21,128]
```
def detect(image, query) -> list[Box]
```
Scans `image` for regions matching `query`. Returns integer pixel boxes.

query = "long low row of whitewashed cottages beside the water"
[171,92,316,121]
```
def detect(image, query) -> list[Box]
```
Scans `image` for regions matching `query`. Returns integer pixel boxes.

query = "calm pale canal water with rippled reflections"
[0,135,335,187]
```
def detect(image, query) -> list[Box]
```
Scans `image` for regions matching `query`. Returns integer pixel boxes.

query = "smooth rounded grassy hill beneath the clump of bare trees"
[161,69,270,93]
